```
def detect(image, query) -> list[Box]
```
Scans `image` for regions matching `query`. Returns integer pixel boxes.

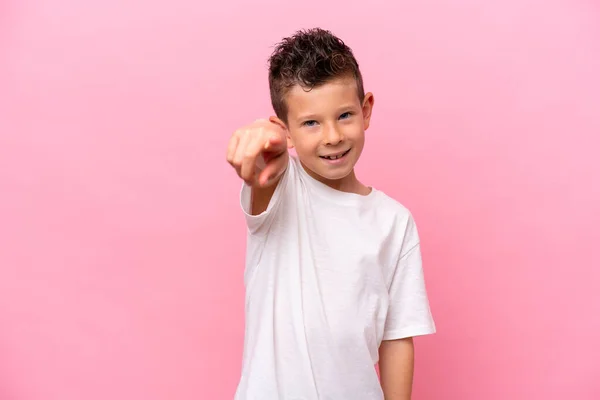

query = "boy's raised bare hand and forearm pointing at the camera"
[227,117,289,215]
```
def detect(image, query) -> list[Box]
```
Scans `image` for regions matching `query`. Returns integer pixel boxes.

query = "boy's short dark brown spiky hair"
[269,28,365,123]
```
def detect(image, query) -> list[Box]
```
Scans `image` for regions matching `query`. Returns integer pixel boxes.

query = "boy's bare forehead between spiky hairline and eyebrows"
[285,78,359,116]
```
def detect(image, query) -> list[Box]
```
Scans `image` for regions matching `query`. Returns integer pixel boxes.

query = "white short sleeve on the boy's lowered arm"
[383,221,436,340]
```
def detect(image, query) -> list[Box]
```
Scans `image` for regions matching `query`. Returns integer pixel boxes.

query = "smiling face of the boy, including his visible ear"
[285,77,373,184]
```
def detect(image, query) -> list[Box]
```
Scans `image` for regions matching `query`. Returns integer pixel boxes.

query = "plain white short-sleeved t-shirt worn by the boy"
[235,156,435,400]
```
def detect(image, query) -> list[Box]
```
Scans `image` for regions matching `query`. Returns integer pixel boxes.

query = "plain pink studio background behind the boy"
[0,0,600,400]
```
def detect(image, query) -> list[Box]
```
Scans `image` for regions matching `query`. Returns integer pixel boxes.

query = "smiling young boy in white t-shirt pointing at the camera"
[227,29,435,400]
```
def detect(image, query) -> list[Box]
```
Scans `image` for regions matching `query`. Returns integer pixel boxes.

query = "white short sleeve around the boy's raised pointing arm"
[240,157,292,235]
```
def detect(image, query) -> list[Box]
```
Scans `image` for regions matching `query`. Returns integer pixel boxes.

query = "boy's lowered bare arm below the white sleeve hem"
[379,338,415,400]
